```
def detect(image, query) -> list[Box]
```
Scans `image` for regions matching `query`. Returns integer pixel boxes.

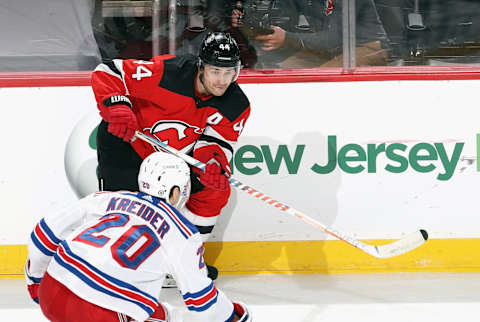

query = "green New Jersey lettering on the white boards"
[233,135,466,181]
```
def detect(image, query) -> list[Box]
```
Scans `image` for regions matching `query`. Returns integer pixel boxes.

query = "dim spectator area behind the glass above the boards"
[0,0,480,71]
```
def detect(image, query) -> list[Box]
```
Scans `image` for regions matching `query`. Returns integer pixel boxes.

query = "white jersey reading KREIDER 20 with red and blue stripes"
[27,191,233,321]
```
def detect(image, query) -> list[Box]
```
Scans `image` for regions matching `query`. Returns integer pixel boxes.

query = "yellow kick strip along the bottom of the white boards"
[0,238,480,278]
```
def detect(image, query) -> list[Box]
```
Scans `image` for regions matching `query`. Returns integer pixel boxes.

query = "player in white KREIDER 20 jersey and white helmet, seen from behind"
[25,152,251,322]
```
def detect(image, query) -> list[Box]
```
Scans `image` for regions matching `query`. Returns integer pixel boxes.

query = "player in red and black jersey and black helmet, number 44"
[92,32,250,277]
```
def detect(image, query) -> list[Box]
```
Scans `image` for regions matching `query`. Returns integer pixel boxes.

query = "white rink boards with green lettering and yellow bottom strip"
[0,80,480,275]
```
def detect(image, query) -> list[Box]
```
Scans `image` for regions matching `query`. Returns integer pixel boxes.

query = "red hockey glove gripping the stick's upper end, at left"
[106,105,139,142]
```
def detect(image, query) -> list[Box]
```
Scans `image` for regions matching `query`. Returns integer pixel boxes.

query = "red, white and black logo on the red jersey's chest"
[150,120,203,152]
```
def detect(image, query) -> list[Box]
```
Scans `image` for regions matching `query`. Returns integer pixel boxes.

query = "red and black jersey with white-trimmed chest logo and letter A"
[92,55,250,164]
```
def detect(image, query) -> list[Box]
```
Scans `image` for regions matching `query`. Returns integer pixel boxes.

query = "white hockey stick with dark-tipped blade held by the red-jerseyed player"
[135,131,428,258]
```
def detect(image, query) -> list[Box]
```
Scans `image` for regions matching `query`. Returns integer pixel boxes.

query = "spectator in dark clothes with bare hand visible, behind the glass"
[232,0,387,68]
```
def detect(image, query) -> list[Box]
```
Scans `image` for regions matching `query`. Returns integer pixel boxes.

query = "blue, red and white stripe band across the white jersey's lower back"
[54,243,158,315]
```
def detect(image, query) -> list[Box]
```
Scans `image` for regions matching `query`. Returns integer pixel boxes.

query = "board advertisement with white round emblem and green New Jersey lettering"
[65,113,480,197]
